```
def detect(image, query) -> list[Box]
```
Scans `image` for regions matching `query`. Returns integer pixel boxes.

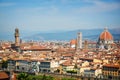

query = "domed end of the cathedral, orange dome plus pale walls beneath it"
[97,28,113,49]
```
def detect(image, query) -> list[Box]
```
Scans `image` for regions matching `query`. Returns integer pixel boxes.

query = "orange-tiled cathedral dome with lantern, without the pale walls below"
[99,28,113,40]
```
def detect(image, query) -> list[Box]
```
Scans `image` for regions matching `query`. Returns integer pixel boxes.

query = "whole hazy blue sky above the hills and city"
[0,0,120,33]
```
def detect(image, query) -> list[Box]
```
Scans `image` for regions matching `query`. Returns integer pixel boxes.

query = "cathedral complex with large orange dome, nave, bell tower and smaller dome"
[70,28,114,50]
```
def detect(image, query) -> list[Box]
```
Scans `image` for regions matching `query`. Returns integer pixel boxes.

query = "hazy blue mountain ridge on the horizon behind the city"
[23,29,120,41]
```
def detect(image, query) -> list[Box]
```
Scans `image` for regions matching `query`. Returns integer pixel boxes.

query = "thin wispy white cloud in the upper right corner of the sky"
[75,0,120,13]
